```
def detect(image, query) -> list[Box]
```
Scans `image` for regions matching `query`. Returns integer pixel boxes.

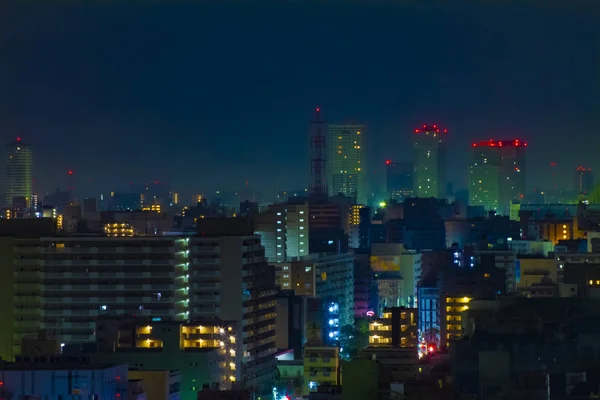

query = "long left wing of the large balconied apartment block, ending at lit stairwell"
[0,236,189,359]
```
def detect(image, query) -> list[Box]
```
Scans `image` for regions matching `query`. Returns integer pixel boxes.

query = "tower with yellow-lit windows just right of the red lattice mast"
[328,125,369,205]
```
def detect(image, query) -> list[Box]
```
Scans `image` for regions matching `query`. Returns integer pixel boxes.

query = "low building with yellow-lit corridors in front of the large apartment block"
[91,317,237,400]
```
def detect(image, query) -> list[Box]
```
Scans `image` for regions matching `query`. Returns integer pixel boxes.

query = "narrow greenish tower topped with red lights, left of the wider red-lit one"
[413,125,448,198]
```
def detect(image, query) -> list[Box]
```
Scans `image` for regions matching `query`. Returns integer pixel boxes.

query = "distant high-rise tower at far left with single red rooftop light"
[4,138,33,208]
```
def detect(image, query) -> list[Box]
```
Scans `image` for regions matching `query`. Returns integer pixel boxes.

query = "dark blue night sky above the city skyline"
[0,1,600,200]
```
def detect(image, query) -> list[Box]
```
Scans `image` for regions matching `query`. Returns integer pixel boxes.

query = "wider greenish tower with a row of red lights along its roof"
[469,139,527,215]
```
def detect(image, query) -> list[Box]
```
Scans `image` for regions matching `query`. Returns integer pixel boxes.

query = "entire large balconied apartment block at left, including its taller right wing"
[0,218,276,391]
